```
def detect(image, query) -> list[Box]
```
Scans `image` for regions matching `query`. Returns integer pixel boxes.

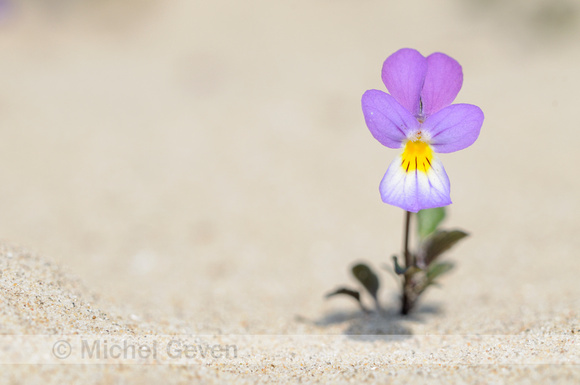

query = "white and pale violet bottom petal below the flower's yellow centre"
[379,156,451,213]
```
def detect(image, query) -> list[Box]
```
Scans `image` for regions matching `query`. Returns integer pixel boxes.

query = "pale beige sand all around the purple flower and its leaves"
[0,0,580,384]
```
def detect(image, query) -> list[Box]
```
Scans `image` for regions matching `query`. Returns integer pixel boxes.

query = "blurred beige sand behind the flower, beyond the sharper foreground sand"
[0,0,580,330]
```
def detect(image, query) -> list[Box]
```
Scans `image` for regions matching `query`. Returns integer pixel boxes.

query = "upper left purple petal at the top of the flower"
[382,48,427,115]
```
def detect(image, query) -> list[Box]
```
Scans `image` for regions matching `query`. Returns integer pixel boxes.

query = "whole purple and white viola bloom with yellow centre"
[362,48,483,212]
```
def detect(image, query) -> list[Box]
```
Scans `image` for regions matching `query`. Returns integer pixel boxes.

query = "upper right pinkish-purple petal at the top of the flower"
[421,52,463,116]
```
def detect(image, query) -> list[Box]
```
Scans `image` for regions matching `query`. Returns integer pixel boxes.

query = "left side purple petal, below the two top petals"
[362,90,419,148]
